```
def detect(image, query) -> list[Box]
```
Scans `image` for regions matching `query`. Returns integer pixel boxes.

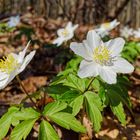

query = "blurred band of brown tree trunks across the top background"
[0,0,140,28]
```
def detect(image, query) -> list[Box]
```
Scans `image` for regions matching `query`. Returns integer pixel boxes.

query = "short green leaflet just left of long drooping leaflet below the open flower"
[70,95,84,116]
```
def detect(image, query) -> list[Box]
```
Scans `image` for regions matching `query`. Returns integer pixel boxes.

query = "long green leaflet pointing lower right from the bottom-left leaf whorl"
[47,112,86,133]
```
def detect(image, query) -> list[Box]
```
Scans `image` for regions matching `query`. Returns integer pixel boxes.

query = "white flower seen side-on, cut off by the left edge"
[0,43,35,89]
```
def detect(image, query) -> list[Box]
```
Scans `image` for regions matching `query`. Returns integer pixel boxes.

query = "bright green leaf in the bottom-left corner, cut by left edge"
[0,107,18,139]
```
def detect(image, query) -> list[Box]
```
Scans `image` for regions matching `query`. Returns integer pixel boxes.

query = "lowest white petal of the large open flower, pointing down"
[99,67,117,84]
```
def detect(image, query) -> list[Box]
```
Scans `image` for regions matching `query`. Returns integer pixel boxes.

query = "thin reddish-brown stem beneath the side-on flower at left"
[16,76,40,109]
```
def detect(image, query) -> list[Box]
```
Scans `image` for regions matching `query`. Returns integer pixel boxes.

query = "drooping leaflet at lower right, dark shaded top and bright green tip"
[107,89,126,125]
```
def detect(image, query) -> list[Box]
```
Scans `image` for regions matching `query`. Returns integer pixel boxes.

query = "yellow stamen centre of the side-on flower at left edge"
[0,54,19,74]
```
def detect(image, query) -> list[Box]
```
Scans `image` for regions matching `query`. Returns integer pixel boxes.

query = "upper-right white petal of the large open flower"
[104,37,125,56]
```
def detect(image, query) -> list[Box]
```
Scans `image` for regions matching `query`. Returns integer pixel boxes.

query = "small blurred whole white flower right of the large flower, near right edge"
[120,26,134,38]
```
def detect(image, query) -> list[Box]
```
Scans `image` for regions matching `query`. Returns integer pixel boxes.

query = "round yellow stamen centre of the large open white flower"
[93,46,111,65]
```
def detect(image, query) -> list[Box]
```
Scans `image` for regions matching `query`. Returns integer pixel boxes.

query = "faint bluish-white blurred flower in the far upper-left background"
[8,16,20,27]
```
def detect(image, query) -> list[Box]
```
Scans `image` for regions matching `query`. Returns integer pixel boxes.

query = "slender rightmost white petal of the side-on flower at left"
[18,51,36,73]
